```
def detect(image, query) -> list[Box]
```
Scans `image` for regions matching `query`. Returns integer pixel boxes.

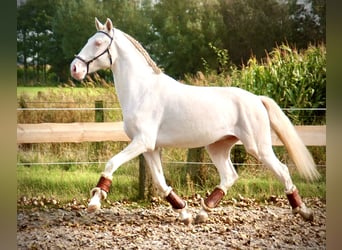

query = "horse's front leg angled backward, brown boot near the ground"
[144,149,192,225]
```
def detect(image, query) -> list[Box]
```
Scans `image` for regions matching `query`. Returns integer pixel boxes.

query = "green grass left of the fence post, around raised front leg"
[17,161,138,203]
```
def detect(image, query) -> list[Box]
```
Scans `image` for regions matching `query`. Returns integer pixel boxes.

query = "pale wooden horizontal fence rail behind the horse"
[17,122,326,146]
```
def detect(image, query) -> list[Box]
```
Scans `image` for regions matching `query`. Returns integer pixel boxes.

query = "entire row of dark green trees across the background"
[17,0,326,84]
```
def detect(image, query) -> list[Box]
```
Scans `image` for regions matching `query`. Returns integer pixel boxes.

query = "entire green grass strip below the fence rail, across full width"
[17,160,326,207]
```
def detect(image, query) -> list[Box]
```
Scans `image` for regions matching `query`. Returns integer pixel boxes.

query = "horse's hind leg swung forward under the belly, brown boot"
[196,137,238,223]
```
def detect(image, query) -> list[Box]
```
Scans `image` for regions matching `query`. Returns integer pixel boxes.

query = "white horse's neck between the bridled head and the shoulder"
[112,30,156,111]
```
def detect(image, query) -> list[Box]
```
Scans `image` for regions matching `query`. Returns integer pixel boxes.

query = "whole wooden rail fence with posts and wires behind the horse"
[17,101,326,198]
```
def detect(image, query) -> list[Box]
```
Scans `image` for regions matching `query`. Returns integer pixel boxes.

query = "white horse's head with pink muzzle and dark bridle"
[70,18,116,80]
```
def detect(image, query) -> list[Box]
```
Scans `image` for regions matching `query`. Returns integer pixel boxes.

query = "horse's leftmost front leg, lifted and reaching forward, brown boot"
[87,140,146,212]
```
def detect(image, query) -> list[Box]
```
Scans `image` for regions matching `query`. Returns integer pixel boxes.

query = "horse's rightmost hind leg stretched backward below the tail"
[254,144,313,220]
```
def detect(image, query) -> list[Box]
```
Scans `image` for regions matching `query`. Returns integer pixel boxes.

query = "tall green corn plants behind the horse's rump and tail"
[230,44,326,124]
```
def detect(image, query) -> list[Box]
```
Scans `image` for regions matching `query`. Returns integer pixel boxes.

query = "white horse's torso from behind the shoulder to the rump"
[158,77,268,147]
